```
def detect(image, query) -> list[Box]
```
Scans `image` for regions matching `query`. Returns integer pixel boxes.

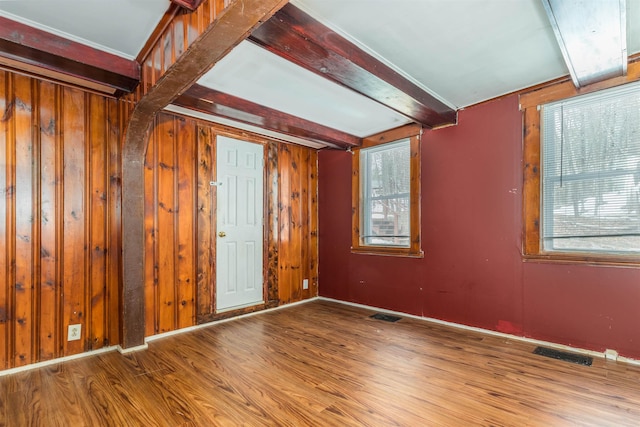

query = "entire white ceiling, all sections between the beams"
[0,0,640,144]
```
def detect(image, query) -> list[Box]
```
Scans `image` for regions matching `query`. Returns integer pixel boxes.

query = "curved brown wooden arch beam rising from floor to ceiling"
[121,0,287,349]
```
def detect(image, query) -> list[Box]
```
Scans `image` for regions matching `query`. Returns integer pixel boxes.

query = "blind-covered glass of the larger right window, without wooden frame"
[541,84,640,254]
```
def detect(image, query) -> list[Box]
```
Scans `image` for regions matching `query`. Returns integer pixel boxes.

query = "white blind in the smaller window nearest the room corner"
[360,139,411,247]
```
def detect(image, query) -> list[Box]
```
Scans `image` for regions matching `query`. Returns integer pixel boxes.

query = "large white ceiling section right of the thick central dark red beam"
[292,0,640,108]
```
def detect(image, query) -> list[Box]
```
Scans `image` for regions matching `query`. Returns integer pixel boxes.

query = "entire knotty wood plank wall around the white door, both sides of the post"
[0,71,318,370]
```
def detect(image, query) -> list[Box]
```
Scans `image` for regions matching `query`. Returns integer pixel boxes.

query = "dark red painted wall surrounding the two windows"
[319,96,640,358]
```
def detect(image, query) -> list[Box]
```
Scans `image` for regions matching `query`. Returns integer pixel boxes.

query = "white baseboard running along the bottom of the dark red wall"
[318,297,640,366]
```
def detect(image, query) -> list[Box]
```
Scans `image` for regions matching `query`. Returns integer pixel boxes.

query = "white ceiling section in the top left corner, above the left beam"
[0,0,170,59]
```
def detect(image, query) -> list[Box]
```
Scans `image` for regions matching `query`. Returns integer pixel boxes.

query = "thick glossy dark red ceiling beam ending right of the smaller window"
[250,4,456,127]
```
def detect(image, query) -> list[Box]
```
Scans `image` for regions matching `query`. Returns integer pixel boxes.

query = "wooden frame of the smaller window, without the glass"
[351,124,424,258]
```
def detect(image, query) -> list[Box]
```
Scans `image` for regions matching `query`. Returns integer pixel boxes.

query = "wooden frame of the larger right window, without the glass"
[520,60,640,266]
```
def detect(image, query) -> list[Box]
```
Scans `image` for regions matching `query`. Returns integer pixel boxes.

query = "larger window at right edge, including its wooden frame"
[520,63,640,264]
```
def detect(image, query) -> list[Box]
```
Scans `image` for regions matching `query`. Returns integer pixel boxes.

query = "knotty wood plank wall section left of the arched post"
[0,70,124,369]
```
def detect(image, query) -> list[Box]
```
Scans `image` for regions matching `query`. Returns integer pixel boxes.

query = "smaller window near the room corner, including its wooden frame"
[352,125,422,256]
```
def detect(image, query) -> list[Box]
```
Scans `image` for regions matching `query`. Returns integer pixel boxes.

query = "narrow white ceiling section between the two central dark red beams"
[198,41,410,137]
